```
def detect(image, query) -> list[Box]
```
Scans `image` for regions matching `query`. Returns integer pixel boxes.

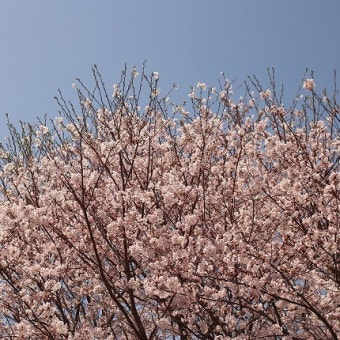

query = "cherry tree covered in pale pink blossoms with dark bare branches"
[0,67,340,339]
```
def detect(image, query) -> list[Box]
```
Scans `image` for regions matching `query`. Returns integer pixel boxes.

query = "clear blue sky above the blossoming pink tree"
[0,0,340,140]
